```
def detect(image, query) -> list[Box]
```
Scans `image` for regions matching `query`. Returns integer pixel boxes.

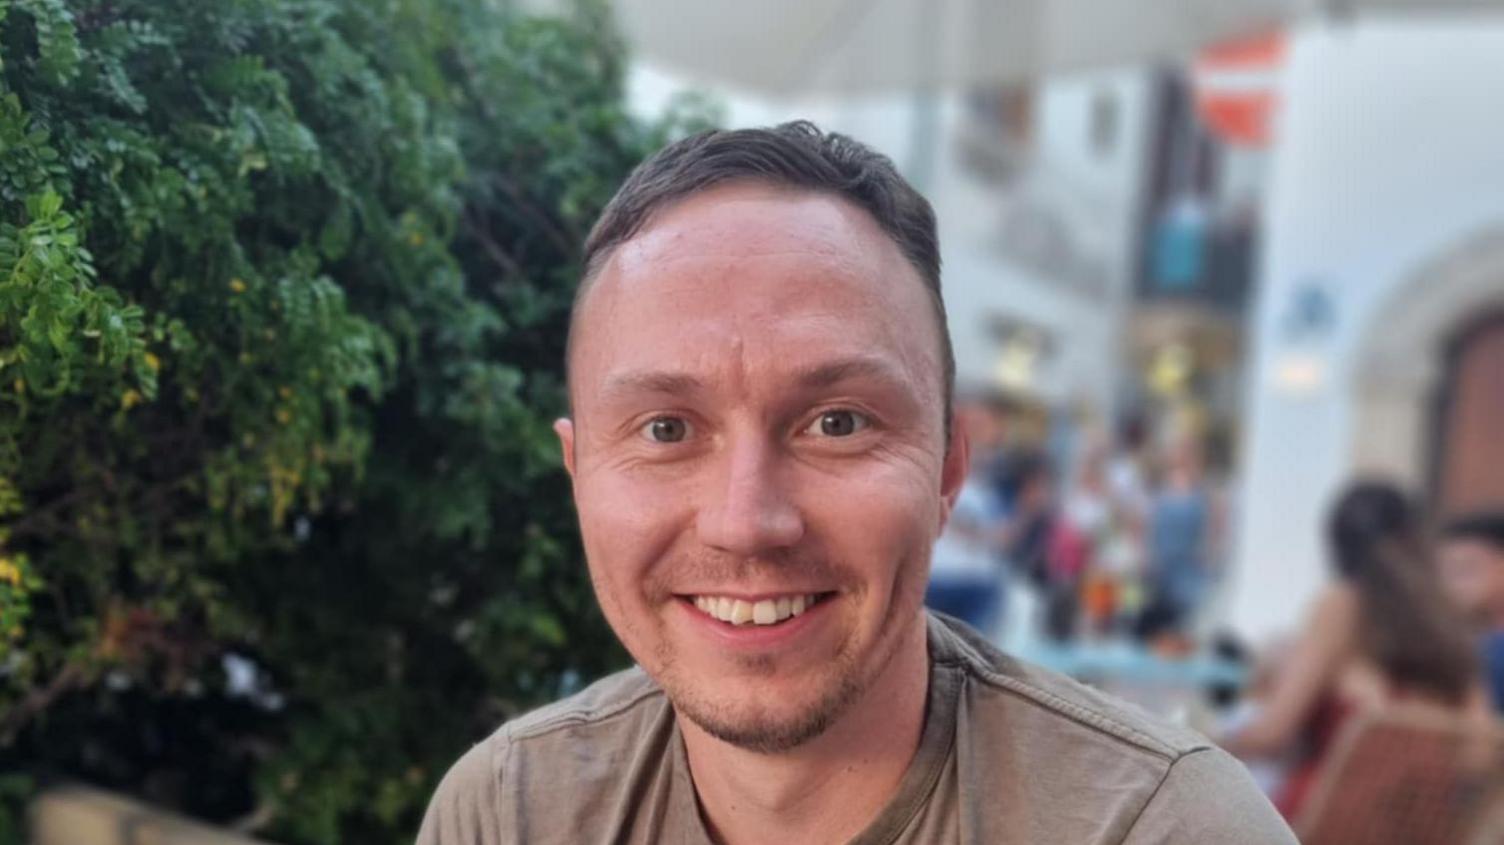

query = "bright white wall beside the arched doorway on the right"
[1230,17,1504,639]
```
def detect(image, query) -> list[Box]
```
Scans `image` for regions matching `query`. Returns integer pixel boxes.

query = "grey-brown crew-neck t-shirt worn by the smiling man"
[418,616,1295,845]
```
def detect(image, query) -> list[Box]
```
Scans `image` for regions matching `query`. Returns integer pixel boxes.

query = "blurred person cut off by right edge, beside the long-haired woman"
[1436,511,1504,711]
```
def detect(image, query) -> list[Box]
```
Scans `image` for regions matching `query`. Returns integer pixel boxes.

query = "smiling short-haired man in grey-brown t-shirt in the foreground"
[420,123,1293,845]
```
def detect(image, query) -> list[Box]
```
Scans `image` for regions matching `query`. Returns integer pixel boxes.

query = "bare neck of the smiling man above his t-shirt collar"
[680,612,929,845]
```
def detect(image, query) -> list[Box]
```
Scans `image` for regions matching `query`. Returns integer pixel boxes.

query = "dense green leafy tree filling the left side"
[0,0,712,843]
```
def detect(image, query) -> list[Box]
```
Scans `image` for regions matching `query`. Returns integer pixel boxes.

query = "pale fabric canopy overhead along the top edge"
[615,0,1504,95]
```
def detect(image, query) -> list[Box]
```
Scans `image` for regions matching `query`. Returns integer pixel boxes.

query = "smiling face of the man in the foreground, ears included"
[555,185,966,752]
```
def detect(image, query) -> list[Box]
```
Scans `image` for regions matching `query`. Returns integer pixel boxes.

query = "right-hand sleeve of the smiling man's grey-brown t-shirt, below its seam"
[1123,749,1298,845]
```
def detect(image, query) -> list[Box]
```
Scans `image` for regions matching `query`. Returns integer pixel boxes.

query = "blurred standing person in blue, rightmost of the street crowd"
[1146,436,1223,635]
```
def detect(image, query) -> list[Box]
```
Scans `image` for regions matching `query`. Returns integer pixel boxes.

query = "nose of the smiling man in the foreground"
[695,436,805,558]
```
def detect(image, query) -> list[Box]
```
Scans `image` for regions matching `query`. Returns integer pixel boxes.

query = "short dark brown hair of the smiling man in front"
[569,120,955,427]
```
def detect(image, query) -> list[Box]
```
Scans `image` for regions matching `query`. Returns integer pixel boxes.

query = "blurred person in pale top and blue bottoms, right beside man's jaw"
[925,400,1005,636]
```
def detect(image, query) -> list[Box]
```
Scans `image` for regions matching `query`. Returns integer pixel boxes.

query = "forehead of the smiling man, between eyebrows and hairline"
[570,183,940,405]
